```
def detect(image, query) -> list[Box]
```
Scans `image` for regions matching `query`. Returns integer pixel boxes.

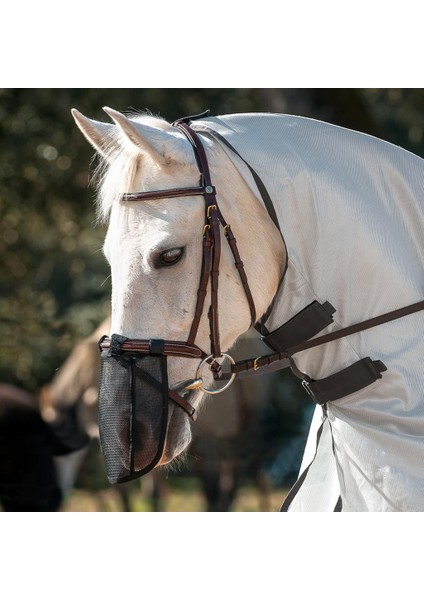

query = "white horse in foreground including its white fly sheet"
[73,108,424,511]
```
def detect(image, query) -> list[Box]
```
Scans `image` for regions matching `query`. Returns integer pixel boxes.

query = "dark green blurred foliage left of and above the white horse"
[0,88,424,391]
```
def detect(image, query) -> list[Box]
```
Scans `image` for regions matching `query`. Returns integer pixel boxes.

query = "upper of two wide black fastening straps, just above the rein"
[262,300,336,352]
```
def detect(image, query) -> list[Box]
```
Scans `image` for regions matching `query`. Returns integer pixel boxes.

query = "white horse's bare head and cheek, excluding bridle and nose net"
[73,108,284,464]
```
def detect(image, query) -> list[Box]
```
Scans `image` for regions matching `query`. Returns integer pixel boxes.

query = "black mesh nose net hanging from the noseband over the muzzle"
[99,335,168,483]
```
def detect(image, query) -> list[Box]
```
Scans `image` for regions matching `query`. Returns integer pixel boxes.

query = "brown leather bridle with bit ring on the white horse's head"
[99,113,256,416]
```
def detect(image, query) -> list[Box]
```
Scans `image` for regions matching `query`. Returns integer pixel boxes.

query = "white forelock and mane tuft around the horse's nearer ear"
[92,112,174,222]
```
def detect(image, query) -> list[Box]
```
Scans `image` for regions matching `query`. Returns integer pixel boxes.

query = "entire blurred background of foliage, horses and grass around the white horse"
[0,88,424,511]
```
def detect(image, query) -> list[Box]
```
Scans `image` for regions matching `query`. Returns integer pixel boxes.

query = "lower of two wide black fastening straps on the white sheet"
[302,357,387,404]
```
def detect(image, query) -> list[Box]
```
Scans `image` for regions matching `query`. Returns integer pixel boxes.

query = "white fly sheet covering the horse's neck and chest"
[193,114,424,511]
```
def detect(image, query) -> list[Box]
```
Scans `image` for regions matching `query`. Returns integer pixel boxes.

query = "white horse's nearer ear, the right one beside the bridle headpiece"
[103,106,177,163]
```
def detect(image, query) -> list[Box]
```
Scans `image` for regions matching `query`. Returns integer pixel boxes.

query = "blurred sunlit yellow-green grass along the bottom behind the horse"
[62,477,287,512]
